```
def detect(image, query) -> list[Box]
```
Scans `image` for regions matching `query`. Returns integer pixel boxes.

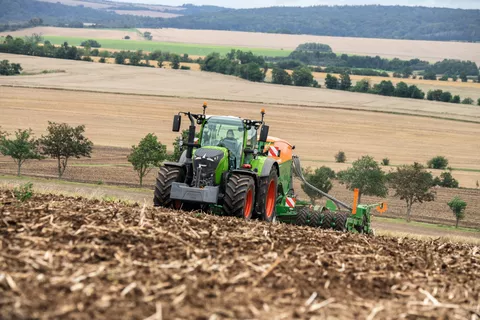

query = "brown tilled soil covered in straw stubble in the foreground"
[0,190,480,320]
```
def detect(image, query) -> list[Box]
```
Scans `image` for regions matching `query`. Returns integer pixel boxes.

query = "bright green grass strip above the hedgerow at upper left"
[44,36,291,57]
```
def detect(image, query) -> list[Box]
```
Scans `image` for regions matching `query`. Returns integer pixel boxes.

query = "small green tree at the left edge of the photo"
[0,129,43,175]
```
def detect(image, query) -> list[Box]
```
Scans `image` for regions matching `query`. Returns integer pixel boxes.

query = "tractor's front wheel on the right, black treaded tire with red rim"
[223,173,255,220]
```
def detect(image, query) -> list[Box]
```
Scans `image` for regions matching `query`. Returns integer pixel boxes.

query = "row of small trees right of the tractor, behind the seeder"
[302,156,466,227]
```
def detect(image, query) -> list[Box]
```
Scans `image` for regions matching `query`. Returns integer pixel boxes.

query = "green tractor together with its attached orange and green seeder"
[154,104,386,233]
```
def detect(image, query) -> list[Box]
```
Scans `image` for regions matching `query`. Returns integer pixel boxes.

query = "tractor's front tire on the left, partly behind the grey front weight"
[153,166,184,209]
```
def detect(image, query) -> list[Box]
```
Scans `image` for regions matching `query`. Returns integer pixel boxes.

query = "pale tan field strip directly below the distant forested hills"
[0,27,480,64]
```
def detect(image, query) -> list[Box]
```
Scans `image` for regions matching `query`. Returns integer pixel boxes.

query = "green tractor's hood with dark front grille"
[193,147,228,187]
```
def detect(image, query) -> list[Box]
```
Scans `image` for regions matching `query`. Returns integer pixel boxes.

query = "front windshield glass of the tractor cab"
[201,117,245,167]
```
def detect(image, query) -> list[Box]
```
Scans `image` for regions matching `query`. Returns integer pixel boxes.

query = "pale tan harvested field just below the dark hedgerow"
[0,54,480,122]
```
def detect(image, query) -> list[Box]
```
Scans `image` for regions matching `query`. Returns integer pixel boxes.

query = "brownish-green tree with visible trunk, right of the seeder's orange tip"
[388,163,435,221]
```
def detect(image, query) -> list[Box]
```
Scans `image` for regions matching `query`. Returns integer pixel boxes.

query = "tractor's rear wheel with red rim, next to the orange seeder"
[257,167,278,222]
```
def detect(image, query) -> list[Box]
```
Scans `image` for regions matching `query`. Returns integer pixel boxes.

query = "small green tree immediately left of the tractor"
[128,133,167,186]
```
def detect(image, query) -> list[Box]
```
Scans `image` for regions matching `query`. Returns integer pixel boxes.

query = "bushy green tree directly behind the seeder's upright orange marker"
[338,156,388,203]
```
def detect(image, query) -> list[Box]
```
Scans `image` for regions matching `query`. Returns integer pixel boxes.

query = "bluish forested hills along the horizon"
[0,0,480,42]
